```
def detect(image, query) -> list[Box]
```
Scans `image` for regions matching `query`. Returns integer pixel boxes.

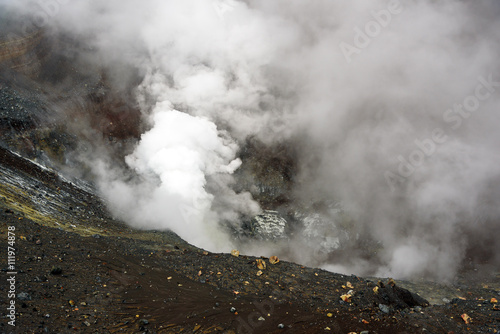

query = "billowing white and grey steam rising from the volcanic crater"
[4,0,500,279]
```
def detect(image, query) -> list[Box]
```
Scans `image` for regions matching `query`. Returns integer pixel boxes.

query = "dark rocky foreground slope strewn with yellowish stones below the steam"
[0,144,500,333]
